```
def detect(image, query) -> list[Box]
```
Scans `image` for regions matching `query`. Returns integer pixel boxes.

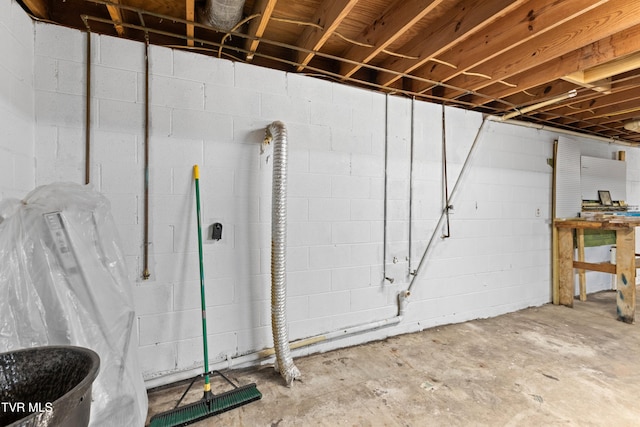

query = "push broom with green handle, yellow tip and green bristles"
[149,165,262,427]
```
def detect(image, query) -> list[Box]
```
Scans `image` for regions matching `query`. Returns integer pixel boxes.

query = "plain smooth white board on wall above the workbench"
[580,156,627,200]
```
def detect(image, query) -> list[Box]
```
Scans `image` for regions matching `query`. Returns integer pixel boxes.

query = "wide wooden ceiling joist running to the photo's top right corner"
[440,0,640,96]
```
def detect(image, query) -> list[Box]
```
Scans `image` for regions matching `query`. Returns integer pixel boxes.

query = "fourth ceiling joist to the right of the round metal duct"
[377,0,527,86]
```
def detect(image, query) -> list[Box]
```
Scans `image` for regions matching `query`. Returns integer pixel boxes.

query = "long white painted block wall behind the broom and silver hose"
[26,23,640,385]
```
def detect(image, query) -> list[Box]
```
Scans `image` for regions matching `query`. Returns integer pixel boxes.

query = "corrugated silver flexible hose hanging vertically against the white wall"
[266,121,301,386]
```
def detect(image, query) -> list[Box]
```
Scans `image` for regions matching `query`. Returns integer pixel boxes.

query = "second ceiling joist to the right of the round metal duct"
[296,0,358,71]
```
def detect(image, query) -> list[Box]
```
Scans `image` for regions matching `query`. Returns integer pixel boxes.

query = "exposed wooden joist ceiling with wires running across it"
[22,0,640,145]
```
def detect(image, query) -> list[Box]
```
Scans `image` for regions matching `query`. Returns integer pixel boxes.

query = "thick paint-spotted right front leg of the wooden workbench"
[616,228,636,323]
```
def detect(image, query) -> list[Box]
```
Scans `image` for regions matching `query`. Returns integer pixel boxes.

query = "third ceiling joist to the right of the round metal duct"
[340,0,444,77]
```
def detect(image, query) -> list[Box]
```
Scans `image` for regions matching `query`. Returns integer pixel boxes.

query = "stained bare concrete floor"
[149,292,640,427]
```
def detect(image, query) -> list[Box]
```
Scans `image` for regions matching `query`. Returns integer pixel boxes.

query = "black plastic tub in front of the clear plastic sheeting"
[0,346,100,427]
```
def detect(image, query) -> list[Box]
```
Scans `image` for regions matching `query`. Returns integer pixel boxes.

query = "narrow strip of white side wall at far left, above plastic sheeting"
[0,0,35,199]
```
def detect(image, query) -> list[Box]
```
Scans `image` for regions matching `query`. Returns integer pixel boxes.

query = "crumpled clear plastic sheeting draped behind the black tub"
[0,183,147,427]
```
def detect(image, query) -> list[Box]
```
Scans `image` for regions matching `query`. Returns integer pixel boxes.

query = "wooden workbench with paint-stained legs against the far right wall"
[553,216,640,323]
